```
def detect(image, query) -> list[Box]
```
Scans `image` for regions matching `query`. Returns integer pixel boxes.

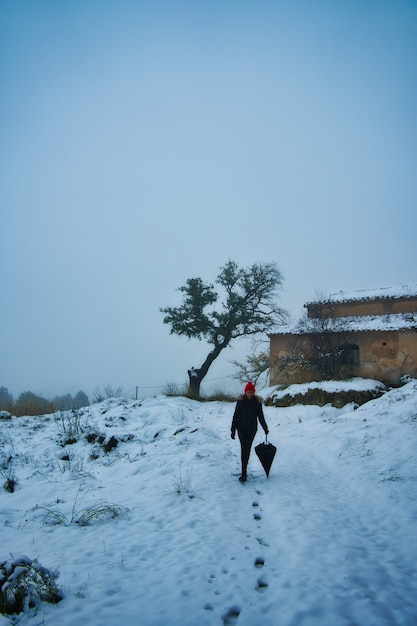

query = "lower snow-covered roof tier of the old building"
[273,313,417,335]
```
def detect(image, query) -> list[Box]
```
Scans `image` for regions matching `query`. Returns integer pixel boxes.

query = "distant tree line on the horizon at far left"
[0,387,90,417]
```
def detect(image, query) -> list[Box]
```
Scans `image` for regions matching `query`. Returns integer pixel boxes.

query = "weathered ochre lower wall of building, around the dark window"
[270,330,417,385]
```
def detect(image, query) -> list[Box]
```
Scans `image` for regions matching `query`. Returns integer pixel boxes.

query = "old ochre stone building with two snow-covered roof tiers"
[269,283,417,385]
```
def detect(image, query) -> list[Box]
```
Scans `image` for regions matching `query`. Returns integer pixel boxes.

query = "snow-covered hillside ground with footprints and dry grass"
[0,380,417,626]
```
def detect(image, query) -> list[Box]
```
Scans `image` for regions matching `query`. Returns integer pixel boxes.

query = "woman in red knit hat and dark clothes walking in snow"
[232,382,269,483]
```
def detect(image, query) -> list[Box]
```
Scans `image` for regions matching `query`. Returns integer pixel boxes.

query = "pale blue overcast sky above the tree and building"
[0,0,417,397]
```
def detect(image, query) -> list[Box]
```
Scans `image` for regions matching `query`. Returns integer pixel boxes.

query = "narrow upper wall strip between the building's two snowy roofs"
[306,297,417,317]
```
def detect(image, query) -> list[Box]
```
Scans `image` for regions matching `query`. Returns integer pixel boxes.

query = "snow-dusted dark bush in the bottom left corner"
[0,556,63,615]
